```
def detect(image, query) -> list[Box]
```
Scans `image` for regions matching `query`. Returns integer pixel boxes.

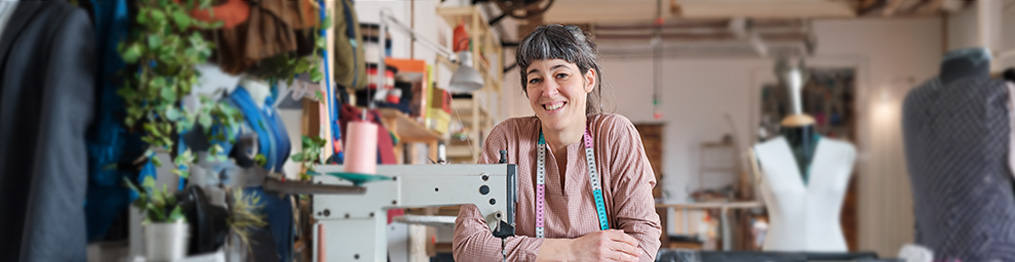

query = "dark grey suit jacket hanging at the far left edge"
[0,1,96,261]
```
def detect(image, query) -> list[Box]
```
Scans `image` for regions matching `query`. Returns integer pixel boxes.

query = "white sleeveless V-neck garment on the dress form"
[752,137,856,252]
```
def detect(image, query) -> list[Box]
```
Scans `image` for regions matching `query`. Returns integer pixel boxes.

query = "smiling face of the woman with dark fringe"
[526,59,596,131]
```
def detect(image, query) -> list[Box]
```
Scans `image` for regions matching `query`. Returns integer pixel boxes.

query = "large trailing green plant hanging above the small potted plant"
[117,0,242,178]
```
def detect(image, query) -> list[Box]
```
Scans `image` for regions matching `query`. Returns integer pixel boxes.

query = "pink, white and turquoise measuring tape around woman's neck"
[536,128,610,238]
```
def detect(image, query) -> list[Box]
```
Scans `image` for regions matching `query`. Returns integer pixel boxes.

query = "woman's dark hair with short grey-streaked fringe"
[515,24,603,115]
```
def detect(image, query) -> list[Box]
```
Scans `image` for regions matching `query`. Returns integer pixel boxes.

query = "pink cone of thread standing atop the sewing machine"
[345,121,378,174]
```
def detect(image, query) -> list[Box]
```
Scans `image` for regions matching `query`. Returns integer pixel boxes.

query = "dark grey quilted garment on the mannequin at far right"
[902,74,1015,261]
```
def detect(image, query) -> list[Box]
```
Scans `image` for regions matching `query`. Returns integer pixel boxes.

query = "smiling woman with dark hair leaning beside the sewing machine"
[454,24,662,261]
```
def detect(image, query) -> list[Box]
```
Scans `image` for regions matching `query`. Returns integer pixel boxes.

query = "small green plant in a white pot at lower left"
[126,177,190,261]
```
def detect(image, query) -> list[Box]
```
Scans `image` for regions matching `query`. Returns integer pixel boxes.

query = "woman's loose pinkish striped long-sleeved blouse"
[453,114,662,261]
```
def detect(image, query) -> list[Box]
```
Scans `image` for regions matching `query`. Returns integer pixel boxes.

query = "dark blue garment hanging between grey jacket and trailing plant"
[84,0,144,241]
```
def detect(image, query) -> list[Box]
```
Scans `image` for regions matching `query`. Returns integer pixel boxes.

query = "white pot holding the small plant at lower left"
[142,221,190,262]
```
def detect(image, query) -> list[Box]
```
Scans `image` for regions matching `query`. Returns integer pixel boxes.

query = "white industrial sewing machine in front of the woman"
[312,163,518,261]
